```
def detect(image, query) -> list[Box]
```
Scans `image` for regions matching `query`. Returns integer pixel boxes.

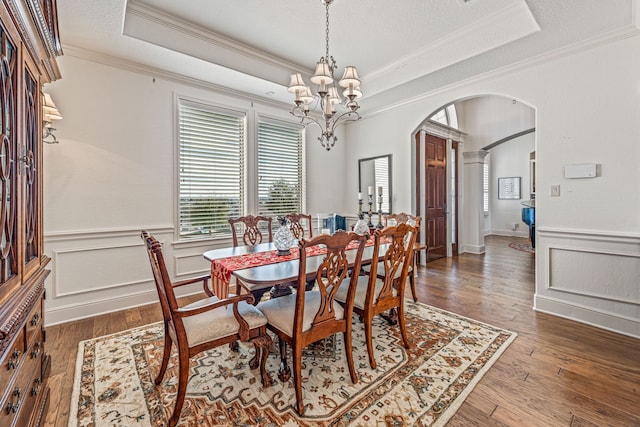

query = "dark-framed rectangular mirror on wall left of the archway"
[358,154,392,214]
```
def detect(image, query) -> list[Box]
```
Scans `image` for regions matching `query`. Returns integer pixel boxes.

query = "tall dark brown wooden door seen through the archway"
[424,134,447,262]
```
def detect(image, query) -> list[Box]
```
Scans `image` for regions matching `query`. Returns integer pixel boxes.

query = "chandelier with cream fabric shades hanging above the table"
[288,0,362,151]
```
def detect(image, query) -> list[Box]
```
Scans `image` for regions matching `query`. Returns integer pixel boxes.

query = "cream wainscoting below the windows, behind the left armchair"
[45,227,215,325]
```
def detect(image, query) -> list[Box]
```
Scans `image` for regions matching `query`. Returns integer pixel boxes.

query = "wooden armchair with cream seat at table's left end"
[141,230,273,427]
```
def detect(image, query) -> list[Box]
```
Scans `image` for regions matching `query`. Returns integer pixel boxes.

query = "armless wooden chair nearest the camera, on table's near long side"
[258,231,366,415]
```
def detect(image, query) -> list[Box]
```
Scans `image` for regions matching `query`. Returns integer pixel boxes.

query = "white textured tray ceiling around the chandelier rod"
[58,0,637,111]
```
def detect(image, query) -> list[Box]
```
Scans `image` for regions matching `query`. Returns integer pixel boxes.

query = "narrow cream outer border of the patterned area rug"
[68,306,518,427]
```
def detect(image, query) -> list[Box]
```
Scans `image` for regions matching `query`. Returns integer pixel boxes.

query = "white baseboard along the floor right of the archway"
[533,294,640,338]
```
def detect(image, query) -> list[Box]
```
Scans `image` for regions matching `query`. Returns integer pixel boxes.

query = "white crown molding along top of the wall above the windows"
[63,44,290,110]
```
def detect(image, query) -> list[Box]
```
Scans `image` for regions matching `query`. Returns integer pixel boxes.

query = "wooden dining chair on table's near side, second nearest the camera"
[336,224,417,369]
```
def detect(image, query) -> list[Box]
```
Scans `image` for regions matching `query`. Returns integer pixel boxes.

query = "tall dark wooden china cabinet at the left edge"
[0,0,62,427]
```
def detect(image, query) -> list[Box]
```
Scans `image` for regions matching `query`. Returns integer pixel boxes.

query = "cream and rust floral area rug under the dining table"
[69,300,516,427]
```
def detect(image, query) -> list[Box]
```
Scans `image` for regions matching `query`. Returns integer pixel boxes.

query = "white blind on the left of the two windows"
[178,99,245,238]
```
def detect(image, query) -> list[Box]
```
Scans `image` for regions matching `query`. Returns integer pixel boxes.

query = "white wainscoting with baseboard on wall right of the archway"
[534,228,640,337]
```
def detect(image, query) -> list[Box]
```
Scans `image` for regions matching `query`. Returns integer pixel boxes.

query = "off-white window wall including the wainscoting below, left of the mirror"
[44,55,346,324]
